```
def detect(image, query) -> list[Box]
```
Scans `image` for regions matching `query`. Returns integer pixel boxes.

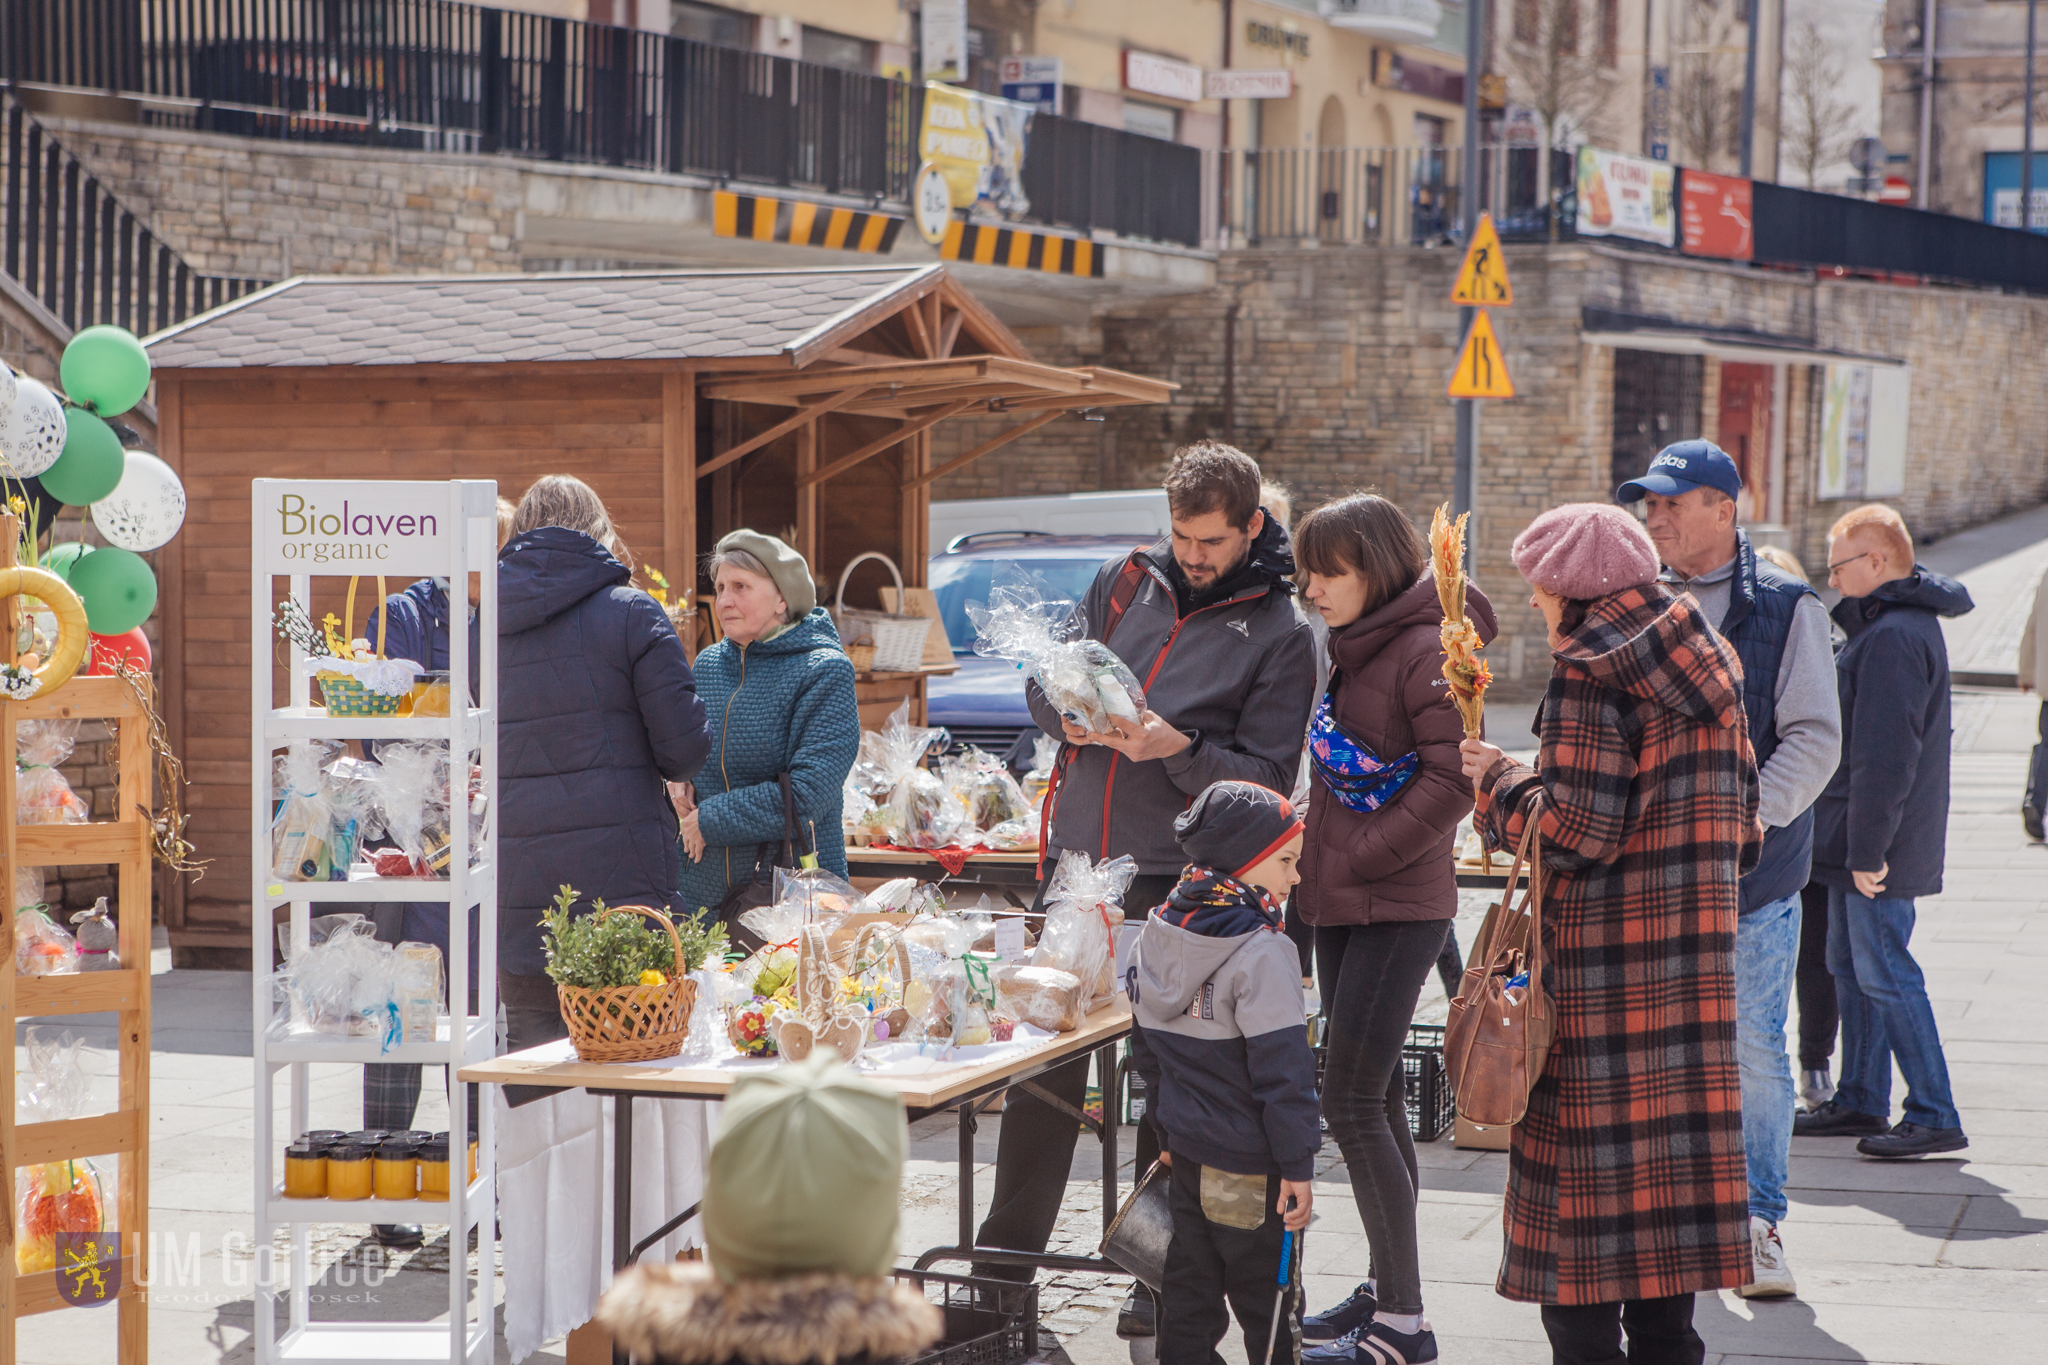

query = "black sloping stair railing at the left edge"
[0,98,264,334]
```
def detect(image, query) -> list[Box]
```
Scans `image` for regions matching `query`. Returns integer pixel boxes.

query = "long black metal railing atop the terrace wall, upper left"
[0,0,1202,246]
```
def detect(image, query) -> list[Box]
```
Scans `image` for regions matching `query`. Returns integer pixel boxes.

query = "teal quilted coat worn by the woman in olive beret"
[678,608,860,909]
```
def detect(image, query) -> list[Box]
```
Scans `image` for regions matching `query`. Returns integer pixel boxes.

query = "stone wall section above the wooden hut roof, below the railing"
[45,117,520,280]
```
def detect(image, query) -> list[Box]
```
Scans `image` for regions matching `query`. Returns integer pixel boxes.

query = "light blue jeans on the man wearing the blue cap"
[1735,892,1800,1228]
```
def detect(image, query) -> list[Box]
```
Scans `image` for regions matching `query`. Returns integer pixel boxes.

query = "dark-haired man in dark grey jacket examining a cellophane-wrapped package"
[975,440,1315,1334]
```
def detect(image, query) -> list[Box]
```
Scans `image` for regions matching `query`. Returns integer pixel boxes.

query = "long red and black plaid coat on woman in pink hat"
[1477,583,1763,1304]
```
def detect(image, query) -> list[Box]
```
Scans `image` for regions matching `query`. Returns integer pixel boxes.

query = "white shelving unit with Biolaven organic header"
[250,479,498,1365]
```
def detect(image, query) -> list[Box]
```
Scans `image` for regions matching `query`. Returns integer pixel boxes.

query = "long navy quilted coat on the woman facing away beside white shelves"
[498,526,711,976]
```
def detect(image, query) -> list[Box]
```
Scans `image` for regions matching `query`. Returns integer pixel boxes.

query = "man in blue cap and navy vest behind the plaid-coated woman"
[1614,440,1841,1297]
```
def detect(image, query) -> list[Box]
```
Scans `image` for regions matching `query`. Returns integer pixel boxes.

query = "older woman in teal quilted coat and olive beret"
[670,530,860,911]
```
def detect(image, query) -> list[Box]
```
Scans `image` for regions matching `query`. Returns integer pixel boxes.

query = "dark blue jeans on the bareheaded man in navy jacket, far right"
[1827,888,1962,1128]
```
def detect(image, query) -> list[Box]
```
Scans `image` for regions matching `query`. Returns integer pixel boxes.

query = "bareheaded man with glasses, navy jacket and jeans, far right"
[1792,503,1972,1158]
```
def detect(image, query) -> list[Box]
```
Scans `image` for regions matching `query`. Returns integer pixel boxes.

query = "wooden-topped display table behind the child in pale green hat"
[457,999,1130,1342]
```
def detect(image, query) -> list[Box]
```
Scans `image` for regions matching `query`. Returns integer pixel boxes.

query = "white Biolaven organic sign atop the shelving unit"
[252,479,455,575]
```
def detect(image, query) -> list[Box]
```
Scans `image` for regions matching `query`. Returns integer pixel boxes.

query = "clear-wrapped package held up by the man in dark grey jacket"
[967,563,1145,735]
